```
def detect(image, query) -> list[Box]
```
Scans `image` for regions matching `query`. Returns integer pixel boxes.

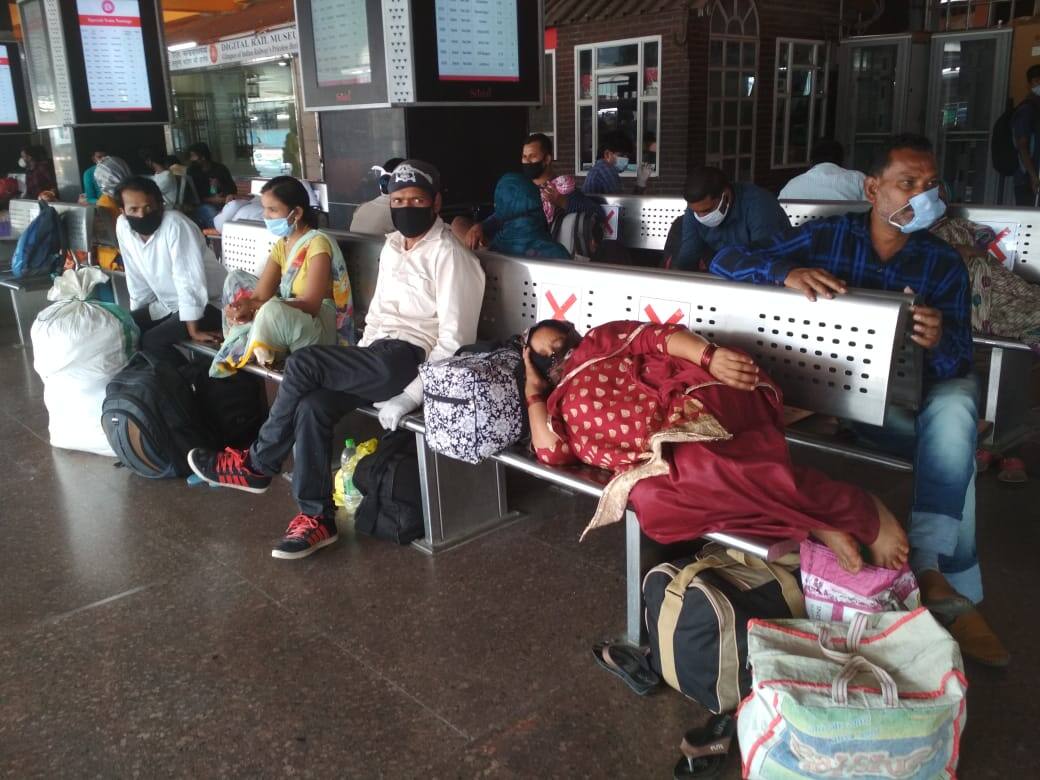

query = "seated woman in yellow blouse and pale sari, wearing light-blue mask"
[210,176,355,376]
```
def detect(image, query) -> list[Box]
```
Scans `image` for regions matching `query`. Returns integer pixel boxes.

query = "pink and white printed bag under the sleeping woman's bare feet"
[800,540,920,623]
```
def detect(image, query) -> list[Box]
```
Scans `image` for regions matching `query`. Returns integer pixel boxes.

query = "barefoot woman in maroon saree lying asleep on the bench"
[524,320,909,571]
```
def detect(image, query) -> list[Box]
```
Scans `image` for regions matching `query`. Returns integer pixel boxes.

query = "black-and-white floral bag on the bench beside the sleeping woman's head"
[419,348,524,463]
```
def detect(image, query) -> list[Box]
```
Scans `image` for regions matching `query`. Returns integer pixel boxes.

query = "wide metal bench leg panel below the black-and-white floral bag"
[412,434,520,554]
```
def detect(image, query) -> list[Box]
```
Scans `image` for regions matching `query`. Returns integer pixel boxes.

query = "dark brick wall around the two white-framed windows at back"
[556,0,838,196]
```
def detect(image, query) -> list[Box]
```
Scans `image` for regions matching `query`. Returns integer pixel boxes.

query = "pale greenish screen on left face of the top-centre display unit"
[311,0,372,87]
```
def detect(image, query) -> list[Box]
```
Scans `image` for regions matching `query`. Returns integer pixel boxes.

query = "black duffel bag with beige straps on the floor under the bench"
[643,543,805,713]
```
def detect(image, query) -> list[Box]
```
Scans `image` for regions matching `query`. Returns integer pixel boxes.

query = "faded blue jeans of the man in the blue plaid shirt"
[853,374,983,602]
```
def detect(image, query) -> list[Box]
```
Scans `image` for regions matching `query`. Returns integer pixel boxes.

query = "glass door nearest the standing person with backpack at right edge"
[928,30,1012,203]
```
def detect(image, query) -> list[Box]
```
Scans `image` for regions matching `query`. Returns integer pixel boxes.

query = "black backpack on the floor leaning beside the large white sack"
[101,353,215,479]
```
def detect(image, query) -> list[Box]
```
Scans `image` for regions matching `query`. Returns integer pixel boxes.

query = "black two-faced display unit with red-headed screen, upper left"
[19,0,170,127]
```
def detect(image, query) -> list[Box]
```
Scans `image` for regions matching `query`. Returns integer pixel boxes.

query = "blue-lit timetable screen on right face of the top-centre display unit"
[435,0,520,82]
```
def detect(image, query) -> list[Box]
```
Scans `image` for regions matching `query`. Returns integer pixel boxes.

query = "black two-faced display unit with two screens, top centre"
[295,0,543,110]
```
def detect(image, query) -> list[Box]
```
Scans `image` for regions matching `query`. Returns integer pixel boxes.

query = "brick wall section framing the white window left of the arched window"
[556,10,690,194]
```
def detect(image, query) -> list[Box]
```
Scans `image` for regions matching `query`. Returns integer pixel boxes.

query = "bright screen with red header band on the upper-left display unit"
[76,0,152,111]
